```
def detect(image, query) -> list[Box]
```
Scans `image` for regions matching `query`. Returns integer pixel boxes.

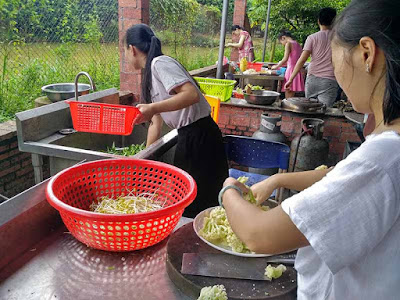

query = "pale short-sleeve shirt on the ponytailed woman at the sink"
[151,55,211,129]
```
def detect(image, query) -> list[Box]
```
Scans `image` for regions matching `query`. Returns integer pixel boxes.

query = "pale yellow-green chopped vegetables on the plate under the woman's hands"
[199,177,269,253]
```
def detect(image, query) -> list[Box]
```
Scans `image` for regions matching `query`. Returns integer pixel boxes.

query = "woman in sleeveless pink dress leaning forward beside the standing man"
[272,30,304,99]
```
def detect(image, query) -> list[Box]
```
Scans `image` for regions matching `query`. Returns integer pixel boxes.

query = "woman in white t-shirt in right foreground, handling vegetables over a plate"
[221,0,400,300]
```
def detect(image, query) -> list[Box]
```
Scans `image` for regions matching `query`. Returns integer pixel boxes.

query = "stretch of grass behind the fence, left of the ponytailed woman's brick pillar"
[0,44,119,122]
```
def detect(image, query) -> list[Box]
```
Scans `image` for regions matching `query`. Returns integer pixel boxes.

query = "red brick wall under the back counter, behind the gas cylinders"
[218,104,360,164]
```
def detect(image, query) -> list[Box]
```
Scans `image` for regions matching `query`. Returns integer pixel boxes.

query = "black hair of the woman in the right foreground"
[333,0,400,124]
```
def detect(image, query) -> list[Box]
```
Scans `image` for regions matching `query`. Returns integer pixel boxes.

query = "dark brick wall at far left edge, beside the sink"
[0,121,49,202]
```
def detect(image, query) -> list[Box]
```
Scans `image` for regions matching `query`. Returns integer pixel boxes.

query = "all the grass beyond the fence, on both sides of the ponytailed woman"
[0,35,283,122]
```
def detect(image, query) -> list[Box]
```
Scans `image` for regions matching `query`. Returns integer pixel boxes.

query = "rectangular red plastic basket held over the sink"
[67,100,140,135]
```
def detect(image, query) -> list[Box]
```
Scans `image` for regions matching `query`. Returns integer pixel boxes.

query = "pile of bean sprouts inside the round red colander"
[90,191,165,214]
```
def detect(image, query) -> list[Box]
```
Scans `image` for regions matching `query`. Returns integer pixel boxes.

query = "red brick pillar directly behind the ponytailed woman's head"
[118,0,150,96]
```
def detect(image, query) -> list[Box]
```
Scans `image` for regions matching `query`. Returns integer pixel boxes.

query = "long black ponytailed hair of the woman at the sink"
[125,24,163,103]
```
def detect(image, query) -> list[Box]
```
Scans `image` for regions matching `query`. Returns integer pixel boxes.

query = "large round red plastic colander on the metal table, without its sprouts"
[46,159,197,251]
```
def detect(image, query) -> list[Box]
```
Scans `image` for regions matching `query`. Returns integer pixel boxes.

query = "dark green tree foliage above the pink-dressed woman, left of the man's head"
[248,0,350,43]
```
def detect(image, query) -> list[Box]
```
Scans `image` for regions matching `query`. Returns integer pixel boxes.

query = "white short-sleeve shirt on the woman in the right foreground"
[282,132,400,300]
